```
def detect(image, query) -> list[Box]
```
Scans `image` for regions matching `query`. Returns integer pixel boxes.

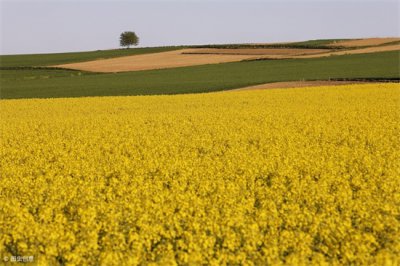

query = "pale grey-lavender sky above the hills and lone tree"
[0,0,400,54]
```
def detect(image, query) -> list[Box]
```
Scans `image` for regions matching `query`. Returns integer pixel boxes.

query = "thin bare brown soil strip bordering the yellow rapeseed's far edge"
[229,80,372,91]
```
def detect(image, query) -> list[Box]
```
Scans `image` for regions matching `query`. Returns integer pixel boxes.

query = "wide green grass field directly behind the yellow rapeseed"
[0,51,400,99]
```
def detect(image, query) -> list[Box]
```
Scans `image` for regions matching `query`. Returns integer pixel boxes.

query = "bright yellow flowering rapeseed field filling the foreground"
[0,84,400,265]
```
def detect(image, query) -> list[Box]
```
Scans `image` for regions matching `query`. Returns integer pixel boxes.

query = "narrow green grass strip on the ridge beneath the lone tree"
[0,46,184,69]
